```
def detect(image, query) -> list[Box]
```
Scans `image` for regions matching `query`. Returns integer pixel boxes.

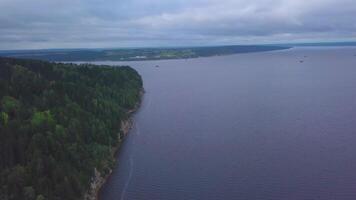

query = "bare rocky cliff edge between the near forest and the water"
[83,88,145,200]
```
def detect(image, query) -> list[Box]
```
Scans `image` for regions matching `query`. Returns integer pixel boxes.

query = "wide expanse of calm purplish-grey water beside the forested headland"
[95,48,356,200]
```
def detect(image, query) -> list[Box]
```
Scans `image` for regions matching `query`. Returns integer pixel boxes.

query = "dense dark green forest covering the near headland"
[0,58,142,200]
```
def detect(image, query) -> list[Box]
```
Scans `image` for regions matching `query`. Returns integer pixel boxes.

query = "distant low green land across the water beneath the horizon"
[0,45,290,61]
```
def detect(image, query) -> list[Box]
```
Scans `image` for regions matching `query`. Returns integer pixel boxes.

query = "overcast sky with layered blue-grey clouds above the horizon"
[0,0,356,49]
